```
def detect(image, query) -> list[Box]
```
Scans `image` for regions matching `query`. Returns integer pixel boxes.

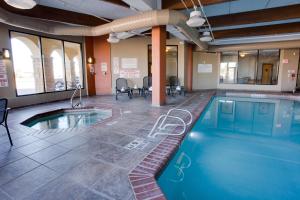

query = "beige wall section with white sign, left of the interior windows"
[193,51,220,90]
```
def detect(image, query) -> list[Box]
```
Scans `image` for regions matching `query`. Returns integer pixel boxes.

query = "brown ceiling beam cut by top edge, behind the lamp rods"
[162,0,235,10]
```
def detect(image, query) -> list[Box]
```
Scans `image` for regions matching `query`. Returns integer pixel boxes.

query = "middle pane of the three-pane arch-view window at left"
[42,38,66,92]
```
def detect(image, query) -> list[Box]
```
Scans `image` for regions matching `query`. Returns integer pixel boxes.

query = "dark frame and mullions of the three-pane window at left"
[8,29,85,97]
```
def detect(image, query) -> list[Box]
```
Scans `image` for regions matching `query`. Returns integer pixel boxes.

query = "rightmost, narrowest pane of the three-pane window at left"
[64,42,83,89]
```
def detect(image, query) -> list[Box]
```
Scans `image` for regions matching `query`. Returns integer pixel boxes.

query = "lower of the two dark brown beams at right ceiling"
[213,22,300,39]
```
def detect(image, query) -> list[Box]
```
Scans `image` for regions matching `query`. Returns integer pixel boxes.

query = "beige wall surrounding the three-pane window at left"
[0,23,86,107]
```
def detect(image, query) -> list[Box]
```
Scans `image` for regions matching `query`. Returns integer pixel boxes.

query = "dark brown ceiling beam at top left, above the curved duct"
[0,1,107,26]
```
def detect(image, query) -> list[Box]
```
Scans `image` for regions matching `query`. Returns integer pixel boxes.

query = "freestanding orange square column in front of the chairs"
[151,26,166,106]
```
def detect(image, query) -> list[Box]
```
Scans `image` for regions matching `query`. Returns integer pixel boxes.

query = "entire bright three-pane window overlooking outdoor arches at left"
[11,32,83,96]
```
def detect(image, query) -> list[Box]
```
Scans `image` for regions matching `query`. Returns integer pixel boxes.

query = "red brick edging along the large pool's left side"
[128,92,216,200]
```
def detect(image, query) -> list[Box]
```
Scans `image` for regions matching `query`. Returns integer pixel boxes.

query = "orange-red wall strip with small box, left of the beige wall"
[94,35,112,95]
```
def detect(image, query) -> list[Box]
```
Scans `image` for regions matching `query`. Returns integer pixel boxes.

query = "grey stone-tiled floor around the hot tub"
[0,92,213,200]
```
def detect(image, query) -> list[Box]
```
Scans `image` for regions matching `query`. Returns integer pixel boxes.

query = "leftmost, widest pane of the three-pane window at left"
[11,32,44,95]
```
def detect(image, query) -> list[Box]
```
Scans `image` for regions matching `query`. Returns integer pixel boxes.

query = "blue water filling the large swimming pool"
[158,97,300,200]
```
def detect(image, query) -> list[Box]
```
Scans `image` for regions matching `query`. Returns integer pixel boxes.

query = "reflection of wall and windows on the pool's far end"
[199,97,300,137]
